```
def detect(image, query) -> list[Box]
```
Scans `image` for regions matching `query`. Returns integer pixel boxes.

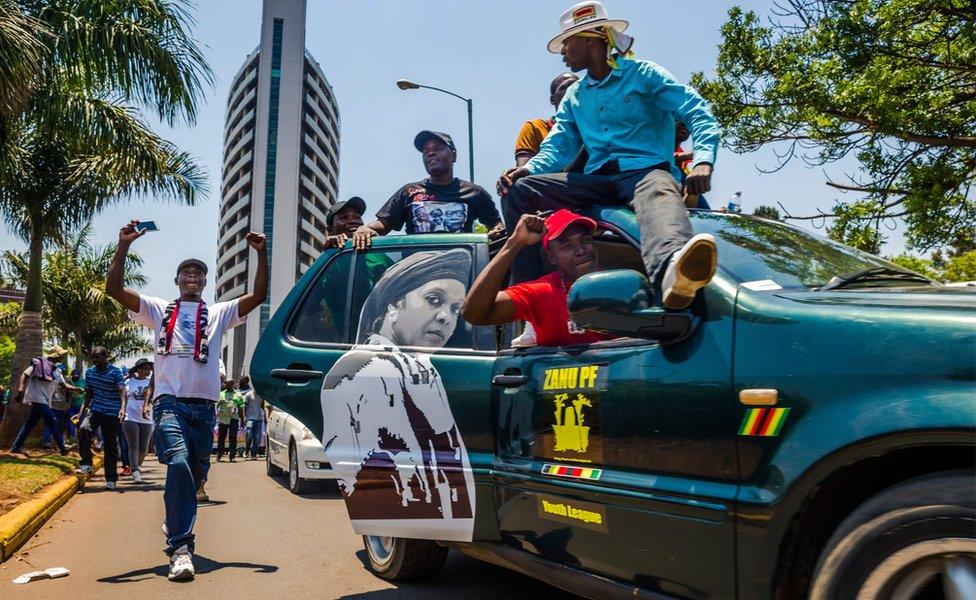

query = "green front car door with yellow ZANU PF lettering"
[492,286,736,598]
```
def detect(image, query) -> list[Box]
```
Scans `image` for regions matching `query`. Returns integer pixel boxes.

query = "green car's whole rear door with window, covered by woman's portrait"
[308,235,497,541]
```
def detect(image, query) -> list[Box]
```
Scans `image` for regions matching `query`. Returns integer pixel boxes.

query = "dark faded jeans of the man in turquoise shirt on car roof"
[502,167,691,287]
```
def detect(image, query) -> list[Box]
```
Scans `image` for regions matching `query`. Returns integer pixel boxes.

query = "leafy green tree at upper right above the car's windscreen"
[693,0,976,252]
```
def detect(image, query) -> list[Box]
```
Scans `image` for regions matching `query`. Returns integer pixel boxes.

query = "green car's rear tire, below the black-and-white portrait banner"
[363,535,447,581]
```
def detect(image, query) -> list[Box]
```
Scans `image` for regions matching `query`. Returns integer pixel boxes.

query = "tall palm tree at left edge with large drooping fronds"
[0,0,212,444]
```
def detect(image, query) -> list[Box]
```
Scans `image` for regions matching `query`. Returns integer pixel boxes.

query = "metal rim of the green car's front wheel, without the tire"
[857,538,976,600]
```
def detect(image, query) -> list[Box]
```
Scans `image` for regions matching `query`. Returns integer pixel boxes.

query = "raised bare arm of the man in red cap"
[461,215,546,325]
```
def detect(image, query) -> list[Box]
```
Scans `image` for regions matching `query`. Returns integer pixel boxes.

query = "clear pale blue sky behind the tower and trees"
[0,0,904,300]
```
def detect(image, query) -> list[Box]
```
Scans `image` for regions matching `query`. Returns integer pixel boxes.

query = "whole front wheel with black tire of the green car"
[810,471,976,600]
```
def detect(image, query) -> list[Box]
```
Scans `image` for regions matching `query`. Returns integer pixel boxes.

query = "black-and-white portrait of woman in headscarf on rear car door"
[321,249,475,541]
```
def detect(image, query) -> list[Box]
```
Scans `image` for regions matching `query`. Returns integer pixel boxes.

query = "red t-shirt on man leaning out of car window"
[505,271,614,346]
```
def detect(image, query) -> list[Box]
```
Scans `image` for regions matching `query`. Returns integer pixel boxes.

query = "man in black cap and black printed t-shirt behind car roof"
[353,131,505,250]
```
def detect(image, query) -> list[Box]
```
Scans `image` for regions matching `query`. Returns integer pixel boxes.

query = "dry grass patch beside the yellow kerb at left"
[0,444,80,514]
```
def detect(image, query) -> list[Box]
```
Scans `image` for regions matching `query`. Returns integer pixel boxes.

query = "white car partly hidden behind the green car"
[265,405,335,494]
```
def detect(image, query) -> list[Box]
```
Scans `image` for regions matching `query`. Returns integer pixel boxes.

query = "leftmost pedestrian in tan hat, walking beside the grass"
[10,346,78,456]
